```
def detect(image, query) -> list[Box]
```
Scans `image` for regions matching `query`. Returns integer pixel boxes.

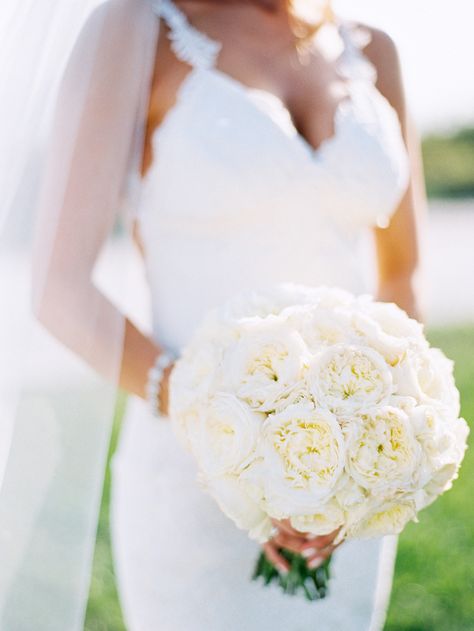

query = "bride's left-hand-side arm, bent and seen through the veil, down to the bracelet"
[33,1,166,410]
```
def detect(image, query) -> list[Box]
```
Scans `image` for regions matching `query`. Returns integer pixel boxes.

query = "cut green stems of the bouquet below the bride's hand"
[252,548,331,601]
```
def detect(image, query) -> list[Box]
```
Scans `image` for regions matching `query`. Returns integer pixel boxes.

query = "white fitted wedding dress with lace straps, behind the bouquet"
[111,0,408,631]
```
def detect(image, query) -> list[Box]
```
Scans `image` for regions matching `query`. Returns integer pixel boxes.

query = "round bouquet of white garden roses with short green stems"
[170,285,468,598]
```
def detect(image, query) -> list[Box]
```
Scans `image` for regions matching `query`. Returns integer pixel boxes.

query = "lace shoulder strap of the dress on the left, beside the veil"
[152,0,222,68]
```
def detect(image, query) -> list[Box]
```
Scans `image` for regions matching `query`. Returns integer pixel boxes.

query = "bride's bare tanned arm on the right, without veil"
[365,29,426,318]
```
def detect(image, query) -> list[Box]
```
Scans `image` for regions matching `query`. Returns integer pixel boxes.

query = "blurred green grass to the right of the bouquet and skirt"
[386,328,474,631]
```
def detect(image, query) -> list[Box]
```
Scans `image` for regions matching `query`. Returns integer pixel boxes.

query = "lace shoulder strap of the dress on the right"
[338,20,377,83]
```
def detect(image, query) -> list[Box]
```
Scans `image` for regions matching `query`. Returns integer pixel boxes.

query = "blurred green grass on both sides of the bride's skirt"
[85,327,474,631]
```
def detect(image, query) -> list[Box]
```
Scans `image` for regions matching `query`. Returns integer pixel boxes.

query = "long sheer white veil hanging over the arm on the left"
[0,0,158,631]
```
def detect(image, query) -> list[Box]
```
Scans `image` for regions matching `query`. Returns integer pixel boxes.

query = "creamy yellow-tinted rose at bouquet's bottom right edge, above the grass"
[347,501,416,539]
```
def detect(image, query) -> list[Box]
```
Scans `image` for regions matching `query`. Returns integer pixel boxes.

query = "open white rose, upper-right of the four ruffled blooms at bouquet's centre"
[307,344,392,416]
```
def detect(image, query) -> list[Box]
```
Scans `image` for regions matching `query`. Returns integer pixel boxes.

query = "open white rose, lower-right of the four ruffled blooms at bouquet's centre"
[347,406,421,494]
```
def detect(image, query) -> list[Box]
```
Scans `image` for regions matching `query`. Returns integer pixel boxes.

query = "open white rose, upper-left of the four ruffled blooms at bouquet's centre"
[220,316,307,411]
